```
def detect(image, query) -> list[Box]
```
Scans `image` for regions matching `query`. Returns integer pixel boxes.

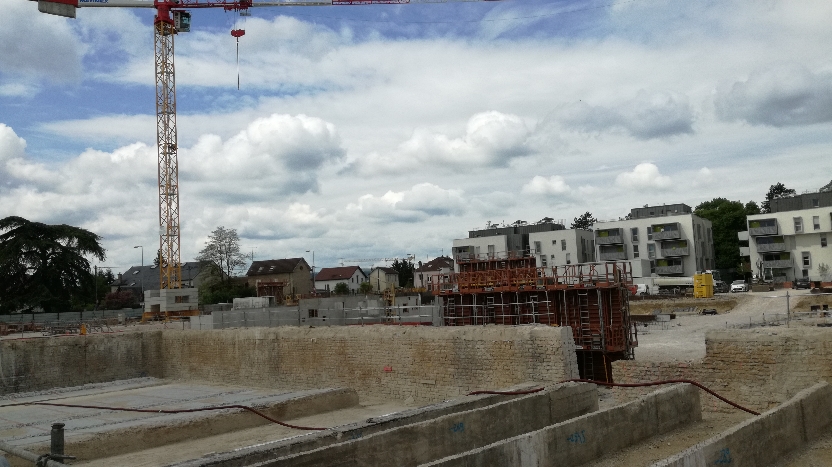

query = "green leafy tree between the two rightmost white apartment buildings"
[693,198,758,269]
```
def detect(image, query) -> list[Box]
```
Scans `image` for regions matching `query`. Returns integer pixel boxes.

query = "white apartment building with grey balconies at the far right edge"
[741,207,832,282]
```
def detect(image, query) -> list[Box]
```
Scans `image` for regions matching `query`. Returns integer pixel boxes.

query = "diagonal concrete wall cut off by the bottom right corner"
[654,382,832,467]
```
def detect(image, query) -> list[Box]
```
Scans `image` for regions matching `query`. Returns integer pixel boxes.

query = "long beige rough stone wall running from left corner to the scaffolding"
[162,326,578,402]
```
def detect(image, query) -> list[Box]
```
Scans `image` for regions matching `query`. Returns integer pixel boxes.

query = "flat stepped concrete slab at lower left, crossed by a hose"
[0,383,358,466]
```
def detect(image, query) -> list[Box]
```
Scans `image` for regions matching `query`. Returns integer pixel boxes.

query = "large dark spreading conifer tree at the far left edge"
[0,216,106,313]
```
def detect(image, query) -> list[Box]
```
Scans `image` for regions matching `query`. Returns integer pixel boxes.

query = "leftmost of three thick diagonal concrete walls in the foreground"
[270,383,598,467]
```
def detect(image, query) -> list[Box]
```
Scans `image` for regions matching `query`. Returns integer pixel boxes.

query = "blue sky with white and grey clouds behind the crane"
[0,0,832,272]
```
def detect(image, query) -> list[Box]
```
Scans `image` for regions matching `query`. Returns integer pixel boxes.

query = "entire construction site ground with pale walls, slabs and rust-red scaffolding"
[0,255,832,466]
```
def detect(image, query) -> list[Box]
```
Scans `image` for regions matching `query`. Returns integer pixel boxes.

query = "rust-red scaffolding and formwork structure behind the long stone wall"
[431,254,638,382]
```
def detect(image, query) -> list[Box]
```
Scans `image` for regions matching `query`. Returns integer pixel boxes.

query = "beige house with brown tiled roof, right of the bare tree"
[246,258,312,295]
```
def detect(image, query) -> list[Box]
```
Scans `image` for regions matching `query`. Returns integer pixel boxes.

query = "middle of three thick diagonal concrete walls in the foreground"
[425,384,702,467]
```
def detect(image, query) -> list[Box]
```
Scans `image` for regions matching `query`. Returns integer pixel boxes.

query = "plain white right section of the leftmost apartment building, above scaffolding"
[529,229,595,267]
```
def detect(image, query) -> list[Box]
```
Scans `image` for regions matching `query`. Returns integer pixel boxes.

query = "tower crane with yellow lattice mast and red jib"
[32,0,498,289]
